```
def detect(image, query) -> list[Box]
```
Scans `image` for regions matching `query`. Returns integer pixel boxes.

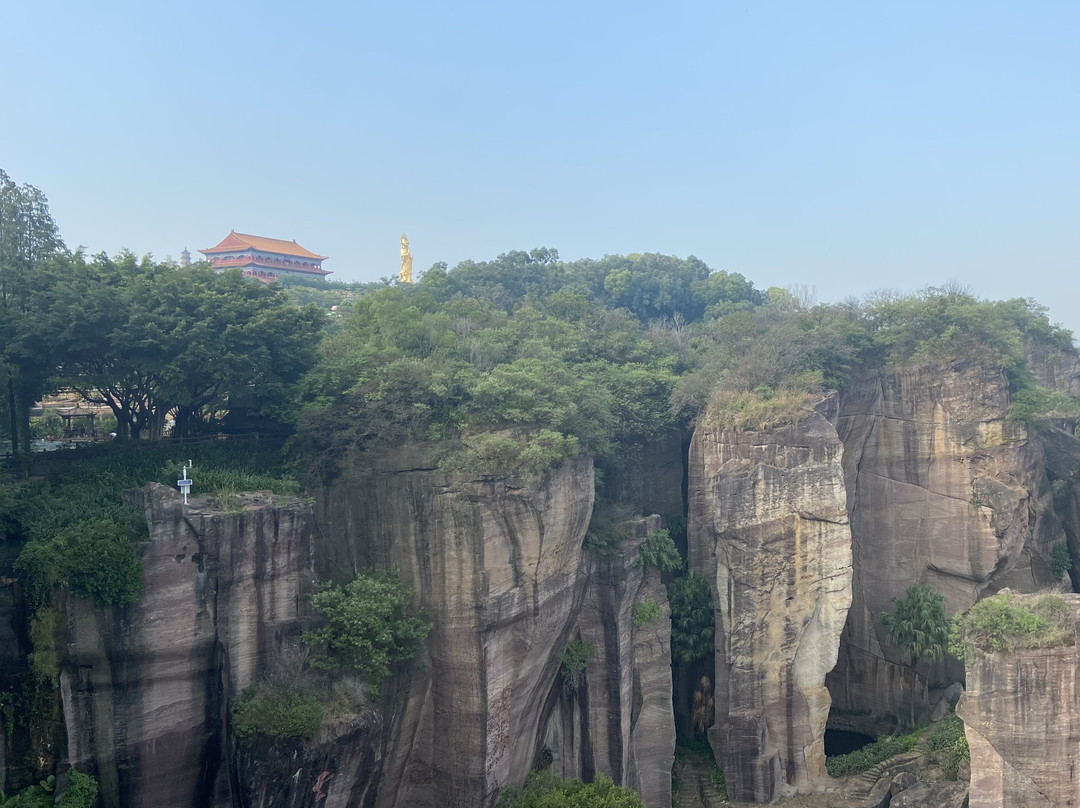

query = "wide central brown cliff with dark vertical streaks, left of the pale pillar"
[318,446,674,808]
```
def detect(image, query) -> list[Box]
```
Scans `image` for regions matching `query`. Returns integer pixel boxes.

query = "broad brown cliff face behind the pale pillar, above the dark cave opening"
[828,363,1065,717]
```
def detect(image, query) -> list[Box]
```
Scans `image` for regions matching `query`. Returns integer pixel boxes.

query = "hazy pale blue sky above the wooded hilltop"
[0,0,1080,332]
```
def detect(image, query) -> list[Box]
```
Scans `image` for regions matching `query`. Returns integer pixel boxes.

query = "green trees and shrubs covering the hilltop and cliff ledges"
[0,171,1080,808]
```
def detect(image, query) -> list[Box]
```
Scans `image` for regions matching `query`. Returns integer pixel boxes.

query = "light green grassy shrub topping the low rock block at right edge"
[949,592,1074,662]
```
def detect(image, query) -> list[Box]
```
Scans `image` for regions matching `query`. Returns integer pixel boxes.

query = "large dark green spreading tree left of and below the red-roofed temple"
[43,253,325,439]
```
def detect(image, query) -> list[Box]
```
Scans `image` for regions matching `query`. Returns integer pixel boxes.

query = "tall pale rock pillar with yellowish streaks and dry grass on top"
[689,399,852,803]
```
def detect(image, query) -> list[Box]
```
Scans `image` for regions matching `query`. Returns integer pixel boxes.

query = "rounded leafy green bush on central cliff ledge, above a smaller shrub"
[301,569,431,699]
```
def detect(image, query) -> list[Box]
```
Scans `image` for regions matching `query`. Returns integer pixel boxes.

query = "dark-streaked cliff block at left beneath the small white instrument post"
[60,484,319,808]
